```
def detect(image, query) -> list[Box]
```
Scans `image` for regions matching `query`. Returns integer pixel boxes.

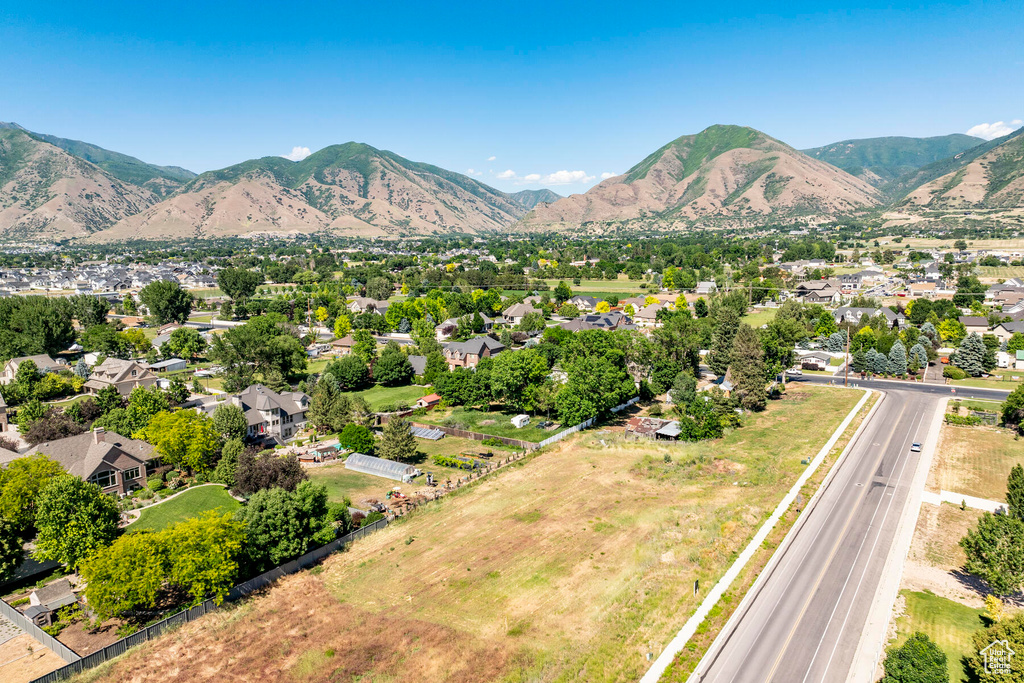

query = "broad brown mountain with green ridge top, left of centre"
[94,142,526,241]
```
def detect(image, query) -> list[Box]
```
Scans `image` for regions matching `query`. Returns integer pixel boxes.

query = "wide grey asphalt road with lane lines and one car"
[690,389,937,683]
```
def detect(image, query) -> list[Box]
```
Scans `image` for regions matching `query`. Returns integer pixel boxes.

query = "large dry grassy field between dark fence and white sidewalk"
[81,386,861,681]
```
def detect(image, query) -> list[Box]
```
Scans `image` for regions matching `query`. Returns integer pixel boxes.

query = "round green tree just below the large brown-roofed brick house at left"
[36,474,120,568]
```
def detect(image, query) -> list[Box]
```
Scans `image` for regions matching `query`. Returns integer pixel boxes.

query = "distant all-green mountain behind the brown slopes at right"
[802,133,982,189]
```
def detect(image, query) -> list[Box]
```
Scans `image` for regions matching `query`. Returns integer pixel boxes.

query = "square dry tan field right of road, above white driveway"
[928,424,1024,502]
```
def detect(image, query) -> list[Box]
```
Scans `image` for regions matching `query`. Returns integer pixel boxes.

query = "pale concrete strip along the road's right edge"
[846,397,949,683]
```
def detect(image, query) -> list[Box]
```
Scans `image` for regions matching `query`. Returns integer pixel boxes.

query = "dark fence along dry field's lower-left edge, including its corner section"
[28,519,388,683]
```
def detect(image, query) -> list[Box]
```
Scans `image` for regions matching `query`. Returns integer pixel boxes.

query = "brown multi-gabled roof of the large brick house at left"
[25,431,157,479]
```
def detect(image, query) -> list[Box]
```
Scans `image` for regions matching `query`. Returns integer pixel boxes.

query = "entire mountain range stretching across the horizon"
[0,123,1024,242]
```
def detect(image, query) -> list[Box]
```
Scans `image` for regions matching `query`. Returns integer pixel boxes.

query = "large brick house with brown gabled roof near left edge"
[26,427,159,496]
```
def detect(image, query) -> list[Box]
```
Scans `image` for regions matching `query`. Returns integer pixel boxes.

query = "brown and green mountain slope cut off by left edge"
[0,128,157,241]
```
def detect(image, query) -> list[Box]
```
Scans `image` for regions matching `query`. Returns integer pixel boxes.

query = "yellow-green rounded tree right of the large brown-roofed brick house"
[141,411,220,472]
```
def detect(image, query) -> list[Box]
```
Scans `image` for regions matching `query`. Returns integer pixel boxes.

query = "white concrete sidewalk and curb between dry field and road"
[640,389,882,683]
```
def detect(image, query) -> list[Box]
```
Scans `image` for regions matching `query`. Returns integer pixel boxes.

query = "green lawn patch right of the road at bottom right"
[890,591,984,683]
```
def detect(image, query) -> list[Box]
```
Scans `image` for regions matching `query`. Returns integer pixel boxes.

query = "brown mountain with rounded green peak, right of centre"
[522,126,880,228]
